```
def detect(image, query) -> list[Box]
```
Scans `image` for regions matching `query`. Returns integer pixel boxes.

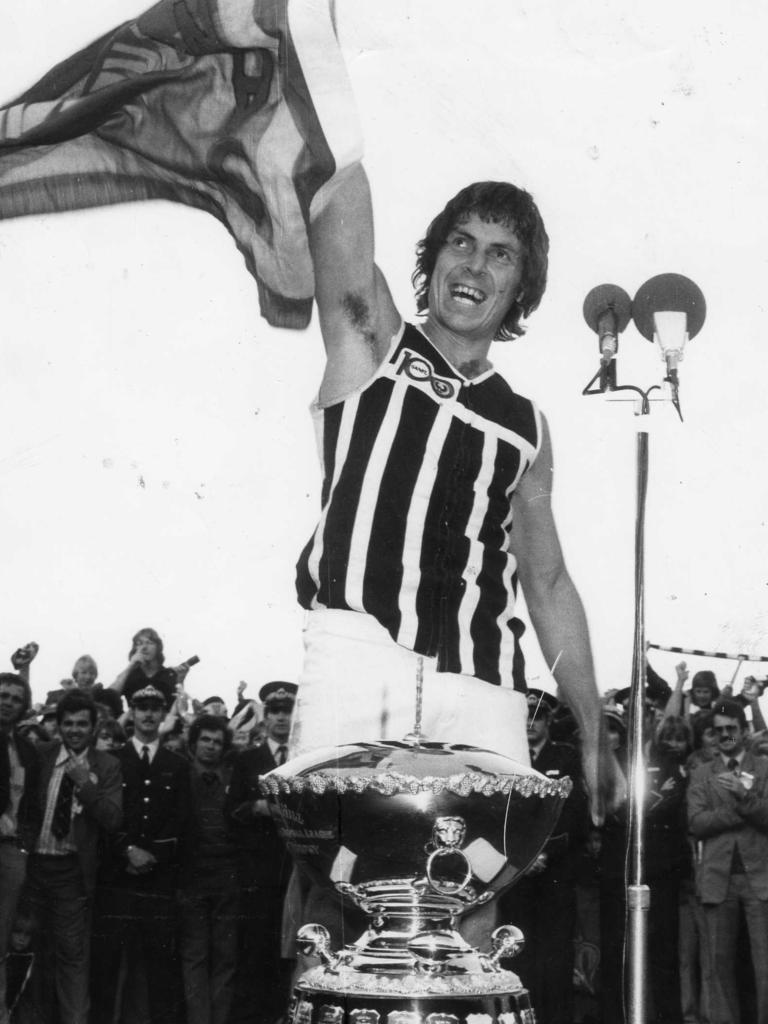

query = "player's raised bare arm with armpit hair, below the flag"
[309,164,400,406]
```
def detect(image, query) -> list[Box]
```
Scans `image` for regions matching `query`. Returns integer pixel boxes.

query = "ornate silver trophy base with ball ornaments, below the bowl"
[291,879,536,1024]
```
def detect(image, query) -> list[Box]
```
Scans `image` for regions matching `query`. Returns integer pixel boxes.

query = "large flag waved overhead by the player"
[0,0,361,328]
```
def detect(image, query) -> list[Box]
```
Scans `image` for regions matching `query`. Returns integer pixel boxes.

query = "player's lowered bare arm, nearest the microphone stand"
[512,411,615,822]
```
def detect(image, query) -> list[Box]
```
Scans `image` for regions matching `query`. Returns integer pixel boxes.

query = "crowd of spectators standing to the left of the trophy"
[0,629,296,1024]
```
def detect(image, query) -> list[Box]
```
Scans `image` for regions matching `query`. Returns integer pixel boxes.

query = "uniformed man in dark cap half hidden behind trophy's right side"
[500,689,589,1024]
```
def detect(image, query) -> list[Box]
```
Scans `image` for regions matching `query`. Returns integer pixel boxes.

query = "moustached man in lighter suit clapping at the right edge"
[688,699,768,1024]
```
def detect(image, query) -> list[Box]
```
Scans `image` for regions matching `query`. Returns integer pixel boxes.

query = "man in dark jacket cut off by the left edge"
[0,672,40,1024]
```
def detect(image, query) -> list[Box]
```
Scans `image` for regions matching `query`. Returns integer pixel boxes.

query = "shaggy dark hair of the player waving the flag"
[411,181,549,341]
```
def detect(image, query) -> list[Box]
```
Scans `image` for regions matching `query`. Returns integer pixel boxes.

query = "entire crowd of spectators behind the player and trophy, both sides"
[0,629,768,1024]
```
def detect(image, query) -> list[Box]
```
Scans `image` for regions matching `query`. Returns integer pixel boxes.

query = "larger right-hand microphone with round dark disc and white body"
[632,273,707,420]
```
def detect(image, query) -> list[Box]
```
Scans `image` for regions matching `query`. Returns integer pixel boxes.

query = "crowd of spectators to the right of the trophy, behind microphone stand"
[552,663,768,1024]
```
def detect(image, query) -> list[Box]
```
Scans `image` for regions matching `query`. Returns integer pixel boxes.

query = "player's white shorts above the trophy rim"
[291,608,530,765]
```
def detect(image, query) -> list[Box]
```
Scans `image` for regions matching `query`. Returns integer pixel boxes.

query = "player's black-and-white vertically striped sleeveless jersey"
[297,325,541,689]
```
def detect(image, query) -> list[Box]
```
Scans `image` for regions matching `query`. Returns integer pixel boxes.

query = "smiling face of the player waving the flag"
[427,213,524,343]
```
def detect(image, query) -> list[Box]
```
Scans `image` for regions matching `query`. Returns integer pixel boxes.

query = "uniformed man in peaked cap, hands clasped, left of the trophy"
[93,683,191,1024]
